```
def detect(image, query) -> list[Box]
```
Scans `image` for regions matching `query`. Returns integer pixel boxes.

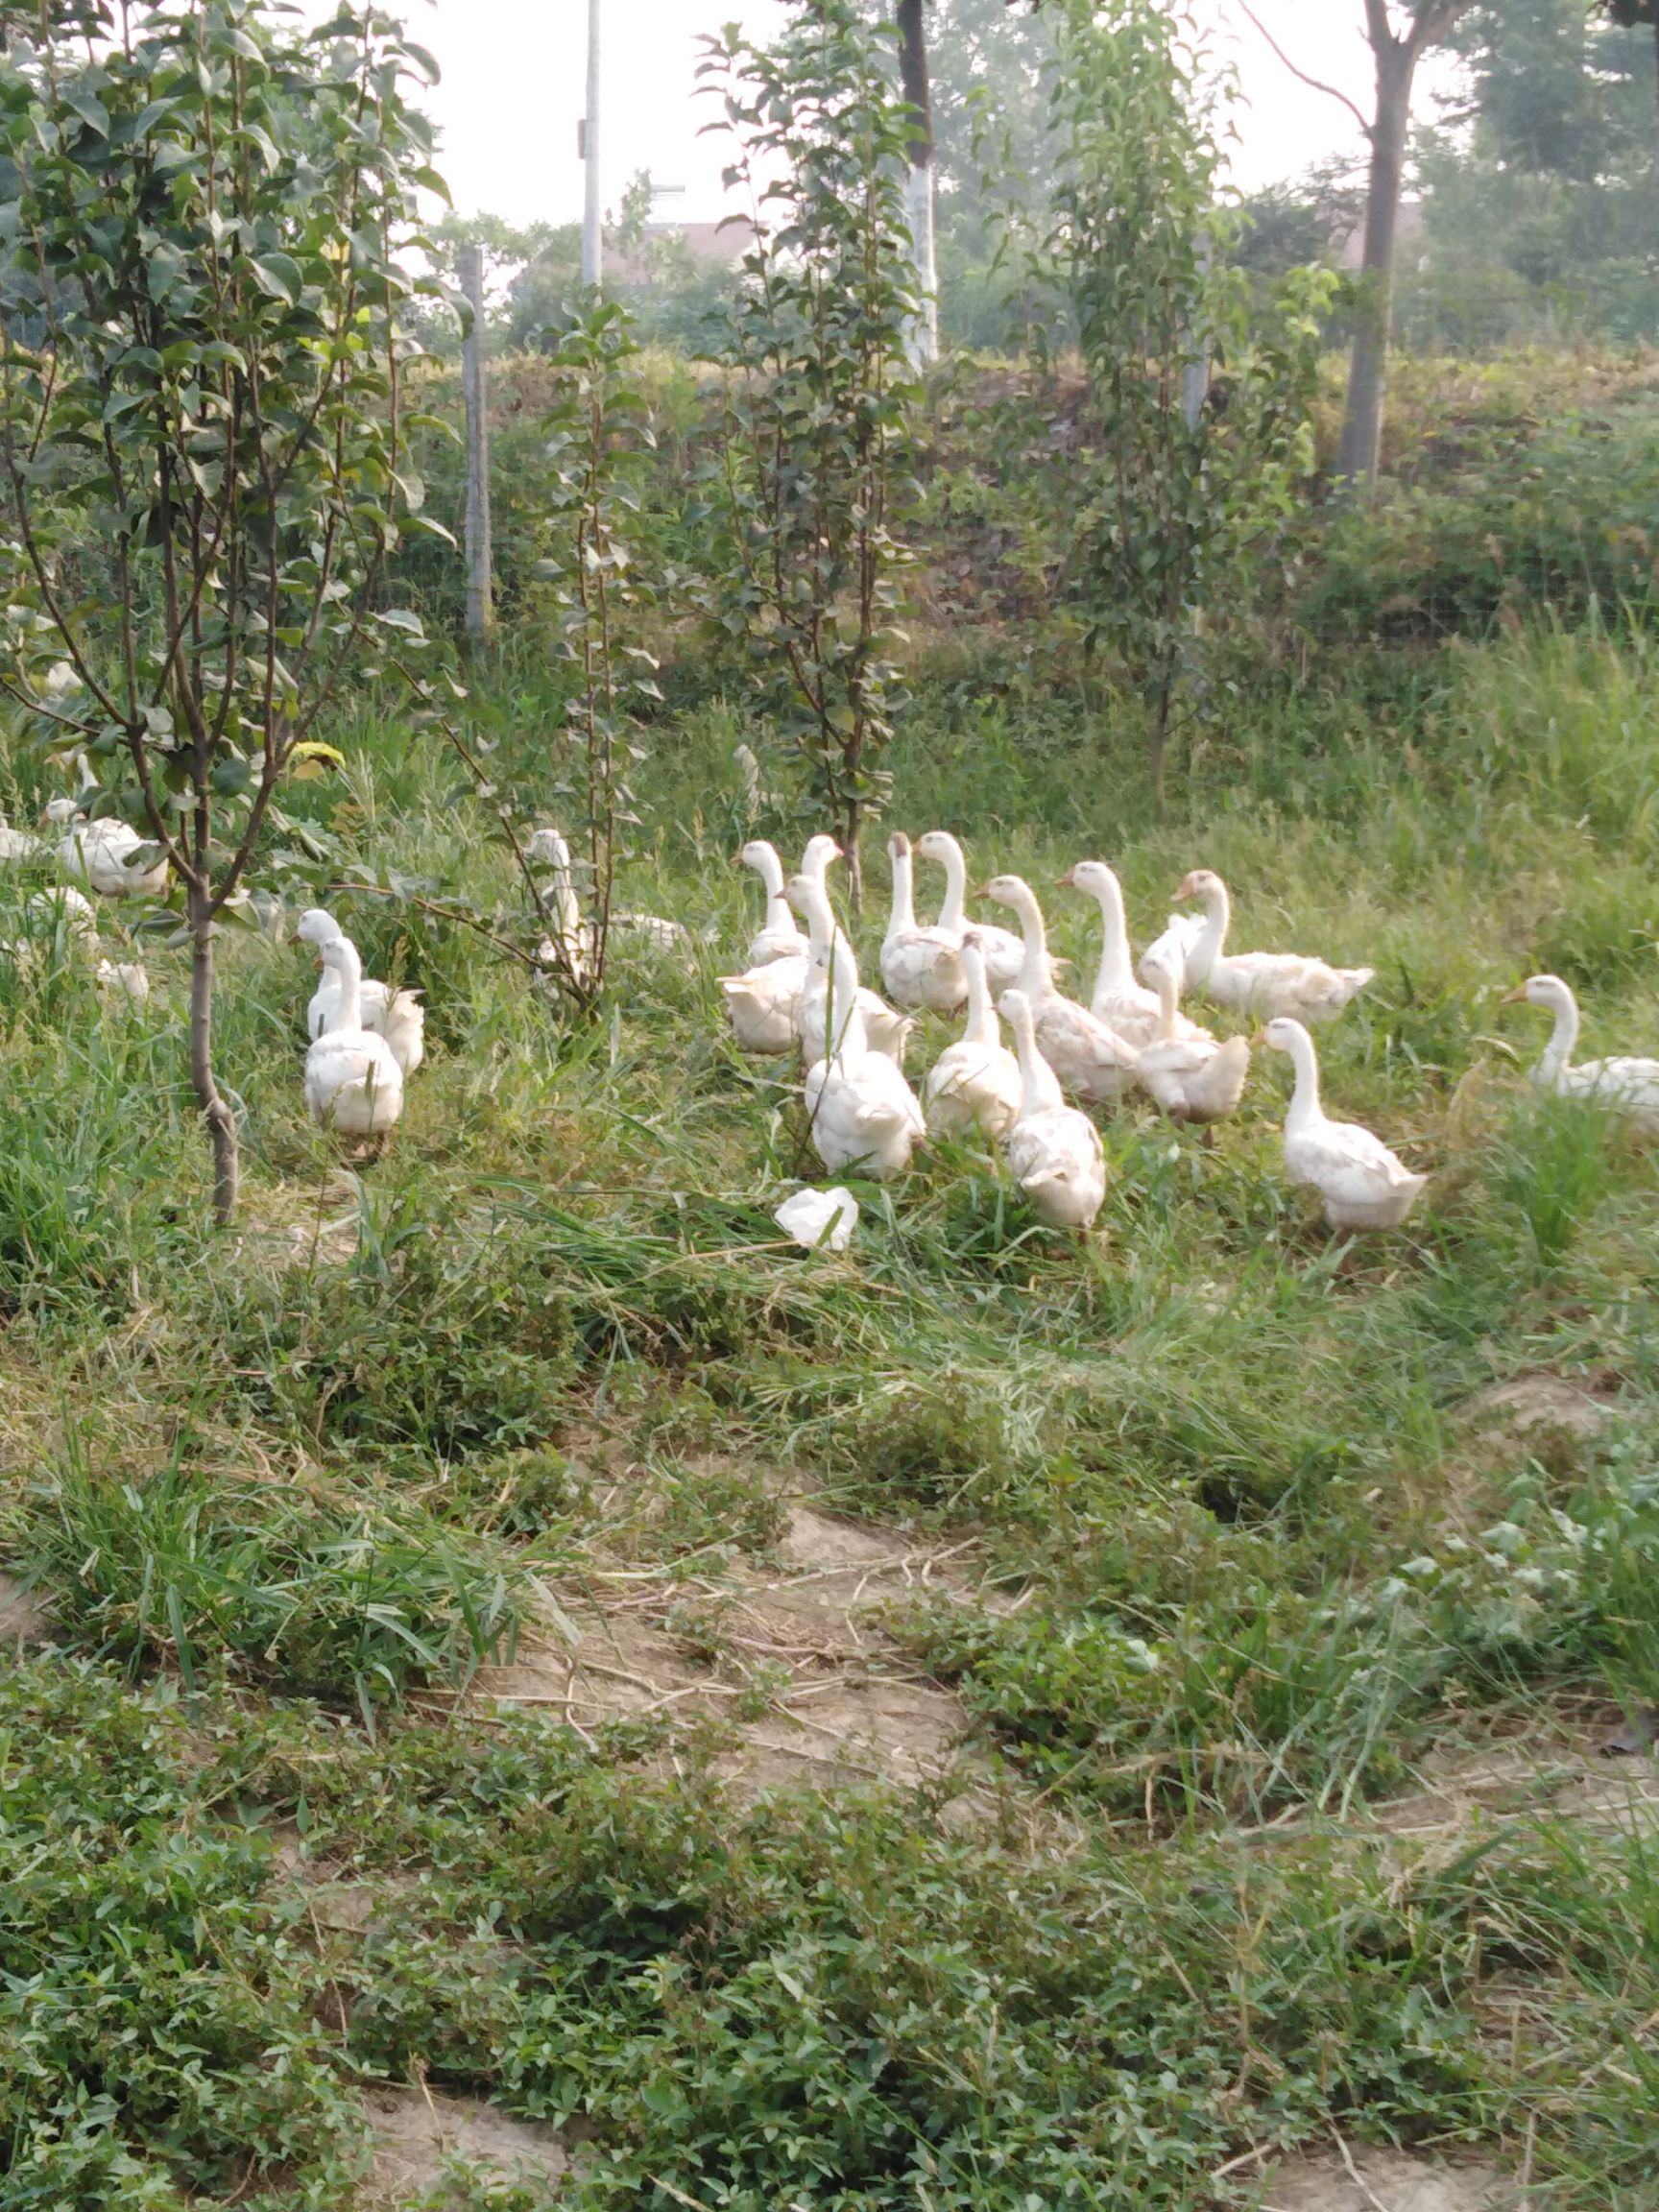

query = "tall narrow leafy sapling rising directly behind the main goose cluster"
[699,0,920,904]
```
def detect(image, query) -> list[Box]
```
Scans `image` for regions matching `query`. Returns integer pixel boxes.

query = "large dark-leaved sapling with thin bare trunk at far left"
[0,0,440,1221]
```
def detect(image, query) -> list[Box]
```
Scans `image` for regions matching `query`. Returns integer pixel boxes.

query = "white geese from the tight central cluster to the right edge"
[721,830,1659,1230]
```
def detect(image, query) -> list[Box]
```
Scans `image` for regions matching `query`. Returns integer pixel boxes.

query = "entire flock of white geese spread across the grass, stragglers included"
[0,801,1659,1230]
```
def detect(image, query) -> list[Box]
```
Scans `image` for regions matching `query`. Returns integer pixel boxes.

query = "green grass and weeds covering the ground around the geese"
[0,614,1659,2212]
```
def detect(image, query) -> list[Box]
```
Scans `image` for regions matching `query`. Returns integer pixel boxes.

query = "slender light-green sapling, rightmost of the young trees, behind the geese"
[1038,0,1330,801]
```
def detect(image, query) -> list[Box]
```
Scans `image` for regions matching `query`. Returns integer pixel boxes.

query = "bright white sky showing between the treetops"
[407,0,1468,224]
